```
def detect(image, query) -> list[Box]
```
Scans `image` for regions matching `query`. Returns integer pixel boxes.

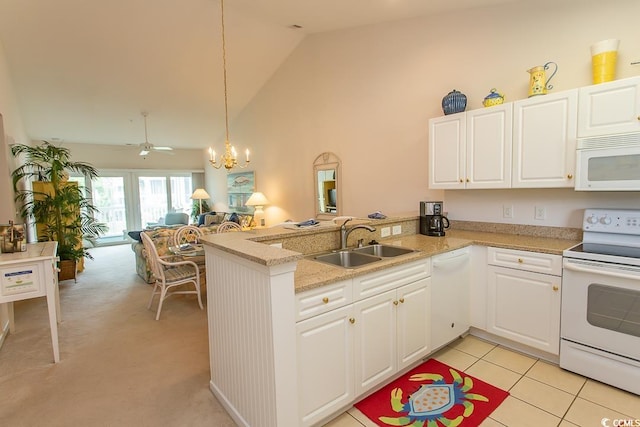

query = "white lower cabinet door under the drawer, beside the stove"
[487,266,562,355]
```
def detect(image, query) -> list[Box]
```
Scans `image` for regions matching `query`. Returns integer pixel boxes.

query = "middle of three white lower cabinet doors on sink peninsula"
[352,289,397,395]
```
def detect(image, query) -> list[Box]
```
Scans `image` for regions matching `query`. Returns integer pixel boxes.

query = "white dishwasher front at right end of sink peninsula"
[431,247,471,350]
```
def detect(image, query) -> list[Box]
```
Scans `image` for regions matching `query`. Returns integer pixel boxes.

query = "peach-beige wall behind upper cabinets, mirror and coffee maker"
[231,0,640,227]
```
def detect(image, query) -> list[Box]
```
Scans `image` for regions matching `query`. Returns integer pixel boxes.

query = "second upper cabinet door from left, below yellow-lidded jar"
[465,103,513,188]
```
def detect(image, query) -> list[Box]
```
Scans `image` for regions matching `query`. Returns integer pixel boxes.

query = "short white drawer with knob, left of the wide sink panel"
[296,280,353,322]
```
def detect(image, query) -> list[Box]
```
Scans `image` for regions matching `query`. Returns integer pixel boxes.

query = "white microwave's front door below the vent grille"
[575,145,640,191]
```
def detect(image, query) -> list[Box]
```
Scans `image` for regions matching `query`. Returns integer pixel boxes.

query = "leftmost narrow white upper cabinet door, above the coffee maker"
[429,113,466,189]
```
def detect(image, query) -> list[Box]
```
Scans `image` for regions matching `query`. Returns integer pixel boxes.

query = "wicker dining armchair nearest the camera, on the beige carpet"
[140,232,204,320]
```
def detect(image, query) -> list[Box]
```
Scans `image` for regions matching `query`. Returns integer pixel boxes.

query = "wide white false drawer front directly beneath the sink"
[353,258,431,301]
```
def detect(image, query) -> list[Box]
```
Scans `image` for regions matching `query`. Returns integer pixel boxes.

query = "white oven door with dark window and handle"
[560,258,640,361]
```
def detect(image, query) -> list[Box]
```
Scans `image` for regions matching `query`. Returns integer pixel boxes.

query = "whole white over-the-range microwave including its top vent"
[575,133,640,191]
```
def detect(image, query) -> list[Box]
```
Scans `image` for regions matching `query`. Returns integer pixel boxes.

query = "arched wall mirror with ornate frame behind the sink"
[313,152,342,218]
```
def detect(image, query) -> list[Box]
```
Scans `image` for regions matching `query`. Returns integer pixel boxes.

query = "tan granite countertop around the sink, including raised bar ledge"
[202,218,580,293]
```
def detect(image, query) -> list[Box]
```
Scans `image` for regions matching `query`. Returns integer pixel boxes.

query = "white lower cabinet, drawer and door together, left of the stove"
[487,248,562,355]
